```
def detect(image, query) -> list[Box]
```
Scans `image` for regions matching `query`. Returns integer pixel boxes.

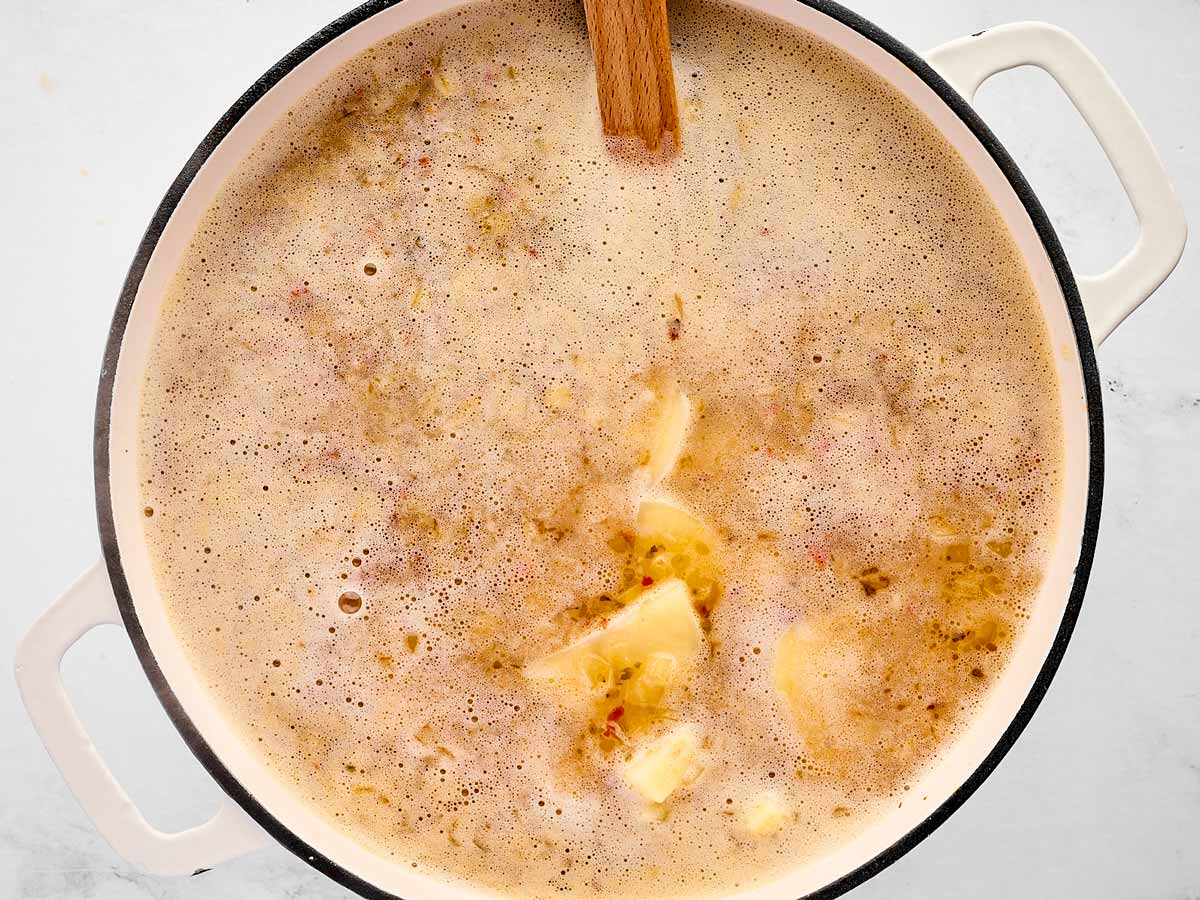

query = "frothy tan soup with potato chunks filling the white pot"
[140,0,1061,896]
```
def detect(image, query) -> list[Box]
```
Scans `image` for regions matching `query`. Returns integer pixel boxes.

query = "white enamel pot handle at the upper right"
[925,22,1188,347]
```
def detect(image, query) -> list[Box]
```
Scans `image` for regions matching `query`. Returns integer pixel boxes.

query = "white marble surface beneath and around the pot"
[0,0,1200,900]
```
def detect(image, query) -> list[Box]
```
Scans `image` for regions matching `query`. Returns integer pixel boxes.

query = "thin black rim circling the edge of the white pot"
[92,0,1104,900]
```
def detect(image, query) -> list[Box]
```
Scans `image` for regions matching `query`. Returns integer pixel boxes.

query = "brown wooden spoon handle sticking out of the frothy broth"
[583,0,679,150]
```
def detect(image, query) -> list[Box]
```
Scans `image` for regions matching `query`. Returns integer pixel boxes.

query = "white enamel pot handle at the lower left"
[16,562,266,875]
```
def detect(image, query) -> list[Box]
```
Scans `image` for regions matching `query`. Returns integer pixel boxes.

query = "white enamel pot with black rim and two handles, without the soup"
[17,0,1187,900]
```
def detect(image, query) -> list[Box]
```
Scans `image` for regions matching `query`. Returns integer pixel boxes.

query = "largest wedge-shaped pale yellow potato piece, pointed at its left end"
[526,578,704,690]
